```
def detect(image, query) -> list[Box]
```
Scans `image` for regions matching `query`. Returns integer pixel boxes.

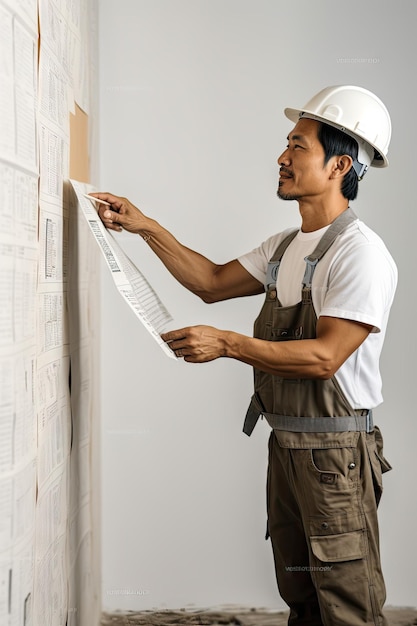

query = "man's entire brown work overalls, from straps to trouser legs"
[244,209,391,626]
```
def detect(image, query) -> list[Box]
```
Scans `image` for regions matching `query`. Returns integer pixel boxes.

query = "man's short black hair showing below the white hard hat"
[317,123,359,200]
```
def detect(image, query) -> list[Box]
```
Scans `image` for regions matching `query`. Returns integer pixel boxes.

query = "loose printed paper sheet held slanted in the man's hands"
[71,180,176,359]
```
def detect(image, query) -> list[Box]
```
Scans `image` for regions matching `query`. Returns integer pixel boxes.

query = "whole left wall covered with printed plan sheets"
[0,0,96,626]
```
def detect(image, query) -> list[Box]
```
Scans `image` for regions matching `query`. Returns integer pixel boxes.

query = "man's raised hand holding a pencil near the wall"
[89,193,149,234]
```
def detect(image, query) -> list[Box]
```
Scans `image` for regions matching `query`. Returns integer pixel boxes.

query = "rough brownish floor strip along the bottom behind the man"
[101,608,417,626]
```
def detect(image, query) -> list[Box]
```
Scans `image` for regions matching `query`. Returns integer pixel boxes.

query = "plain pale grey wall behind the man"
[99,0,417,609]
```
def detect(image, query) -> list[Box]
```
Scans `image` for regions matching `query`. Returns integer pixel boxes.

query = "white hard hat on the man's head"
[284,85,391,178]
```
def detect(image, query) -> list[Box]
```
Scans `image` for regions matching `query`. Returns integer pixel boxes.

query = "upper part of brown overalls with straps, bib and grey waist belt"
[243,208,372,435]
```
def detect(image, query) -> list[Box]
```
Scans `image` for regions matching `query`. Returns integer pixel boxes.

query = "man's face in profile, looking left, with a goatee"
[277,118,334,200]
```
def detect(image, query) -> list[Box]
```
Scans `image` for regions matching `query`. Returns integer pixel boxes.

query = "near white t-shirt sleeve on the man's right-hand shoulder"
[320,243,397,332]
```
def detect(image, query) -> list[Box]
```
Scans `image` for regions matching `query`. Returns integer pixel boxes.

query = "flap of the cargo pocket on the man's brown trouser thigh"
[310,530,366,563]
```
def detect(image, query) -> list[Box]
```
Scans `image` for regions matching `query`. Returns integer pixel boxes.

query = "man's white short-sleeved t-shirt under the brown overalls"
[238,220,397,409]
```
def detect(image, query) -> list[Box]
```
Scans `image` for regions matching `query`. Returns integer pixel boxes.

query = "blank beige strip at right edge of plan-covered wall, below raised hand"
[64,183,101,626]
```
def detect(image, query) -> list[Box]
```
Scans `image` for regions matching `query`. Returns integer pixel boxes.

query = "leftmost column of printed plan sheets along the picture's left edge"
[0,2,38,625]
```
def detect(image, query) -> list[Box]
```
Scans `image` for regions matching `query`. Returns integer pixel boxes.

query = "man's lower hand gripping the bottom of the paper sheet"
[161,326,227,363]
